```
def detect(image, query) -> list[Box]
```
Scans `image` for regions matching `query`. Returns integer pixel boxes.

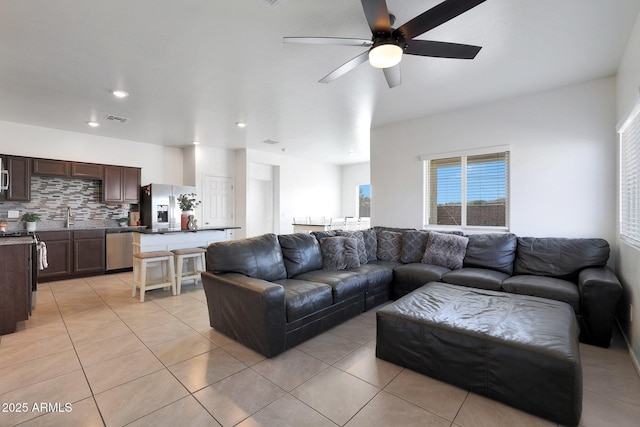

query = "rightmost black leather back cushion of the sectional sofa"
[514,237,609,281]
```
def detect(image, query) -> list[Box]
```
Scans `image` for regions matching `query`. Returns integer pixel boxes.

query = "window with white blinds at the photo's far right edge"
[618,98,640,246]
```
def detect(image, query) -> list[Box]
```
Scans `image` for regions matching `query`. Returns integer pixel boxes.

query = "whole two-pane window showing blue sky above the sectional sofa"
[422,150,509,229]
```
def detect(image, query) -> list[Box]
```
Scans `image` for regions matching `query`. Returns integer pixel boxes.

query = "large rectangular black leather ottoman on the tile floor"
[376,282,582,426]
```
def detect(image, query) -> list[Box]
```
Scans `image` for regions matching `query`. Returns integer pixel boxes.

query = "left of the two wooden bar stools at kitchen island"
[133,251,176,302]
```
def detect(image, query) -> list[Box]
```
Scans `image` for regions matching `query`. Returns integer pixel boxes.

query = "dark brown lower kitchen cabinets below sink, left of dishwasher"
[37,230,105,282]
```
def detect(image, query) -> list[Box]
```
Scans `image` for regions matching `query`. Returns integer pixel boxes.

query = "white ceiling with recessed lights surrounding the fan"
[0,0,640,164]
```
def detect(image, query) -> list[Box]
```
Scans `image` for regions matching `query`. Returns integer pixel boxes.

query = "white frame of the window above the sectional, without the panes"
[420,145,512,233]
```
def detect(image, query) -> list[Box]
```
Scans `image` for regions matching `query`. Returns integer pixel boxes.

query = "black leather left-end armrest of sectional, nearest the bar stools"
[202,271,286,357]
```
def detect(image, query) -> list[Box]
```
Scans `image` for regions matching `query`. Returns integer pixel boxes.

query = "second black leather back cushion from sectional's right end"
[463,233,518,275]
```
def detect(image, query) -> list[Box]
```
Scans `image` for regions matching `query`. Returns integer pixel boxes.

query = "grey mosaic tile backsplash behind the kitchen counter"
[0,175,131,229]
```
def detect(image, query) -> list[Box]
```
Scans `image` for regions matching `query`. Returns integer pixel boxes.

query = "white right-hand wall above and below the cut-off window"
[616,9,640,372]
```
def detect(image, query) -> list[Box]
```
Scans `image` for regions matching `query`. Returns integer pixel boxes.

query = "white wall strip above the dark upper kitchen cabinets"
[0,121,183,184]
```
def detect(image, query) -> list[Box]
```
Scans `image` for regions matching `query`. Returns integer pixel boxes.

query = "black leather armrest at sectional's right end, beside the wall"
[578,267,622,347]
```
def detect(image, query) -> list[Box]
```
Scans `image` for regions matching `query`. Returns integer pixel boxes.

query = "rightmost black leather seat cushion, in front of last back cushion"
[502,275,580,313]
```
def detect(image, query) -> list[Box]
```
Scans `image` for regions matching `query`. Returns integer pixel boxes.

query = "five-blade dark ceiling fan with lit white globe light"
[283,0,486,87]
